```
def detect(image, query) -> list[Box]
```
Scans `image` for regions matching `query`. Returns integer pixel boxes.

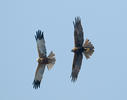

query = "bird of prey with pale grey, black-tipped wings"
[33,30,56,89]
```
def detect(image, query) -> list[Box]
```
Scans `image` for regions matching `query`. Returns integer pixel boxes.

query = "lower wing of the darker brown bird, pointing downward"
[71,53,83,82]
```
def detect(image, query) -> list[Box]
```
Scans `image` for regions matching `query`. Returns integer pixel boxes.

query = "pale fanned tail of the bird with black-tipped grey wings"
[47,51,56,70]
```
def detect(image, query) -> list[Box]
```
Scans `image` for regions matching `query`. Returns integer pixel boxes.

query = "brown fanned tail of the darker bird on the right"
[83,39,94,59]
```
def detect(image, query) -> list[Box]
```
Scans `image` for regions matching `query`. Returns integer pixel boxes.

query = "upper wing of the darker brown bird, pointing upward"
[73,17,84,47]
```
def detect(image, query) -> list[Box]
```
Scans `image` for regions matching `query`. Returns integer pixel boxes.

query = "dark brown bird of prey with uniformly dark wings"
[71,17,94,82]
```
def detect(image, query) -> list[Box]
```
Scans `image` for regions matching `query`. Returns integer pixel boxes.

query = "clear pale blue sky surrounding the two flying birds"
[0,0,127,100]
